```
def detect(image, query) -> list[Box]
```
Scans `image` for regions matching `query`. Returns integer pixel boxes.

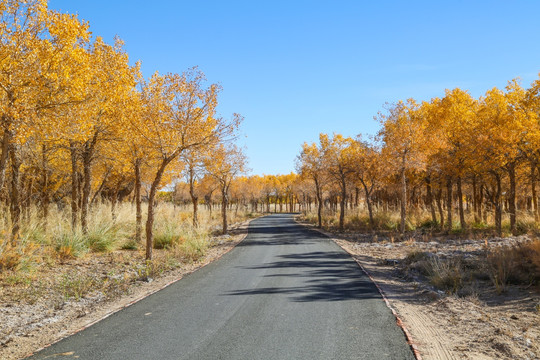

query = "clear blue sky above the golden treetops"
[49,0,540,174]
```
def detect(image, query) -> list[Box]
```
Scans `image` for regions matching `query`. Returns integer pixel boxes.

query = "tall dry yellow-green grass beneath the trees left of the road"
[0,203,255,284]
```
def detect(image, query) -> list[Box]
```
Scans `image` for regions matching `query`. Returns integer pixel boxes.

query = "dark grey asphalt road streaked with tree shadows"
[27,214,414,360]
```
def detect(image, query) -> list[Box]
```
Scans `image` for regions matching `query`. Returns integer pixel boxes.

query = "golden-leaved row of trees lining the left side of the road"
[0,0,245,259]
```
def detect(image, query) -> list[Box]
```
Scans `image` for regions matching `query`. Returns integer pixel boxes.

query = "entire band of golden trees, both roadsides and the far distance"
[4,0,540,266]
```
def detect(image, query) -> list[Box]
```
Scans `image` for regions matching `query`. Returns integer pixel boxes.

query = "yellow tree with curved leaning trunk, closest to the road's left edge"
[138,68,241,259]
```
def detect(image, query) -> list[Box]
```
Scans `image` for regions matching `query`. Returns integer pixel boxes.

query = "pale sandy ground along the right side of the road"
[312,225,540,360]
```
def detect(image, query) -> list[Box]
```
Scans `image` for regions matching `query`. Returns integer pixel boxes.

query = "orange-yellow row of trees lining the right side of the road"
[298,80,540,235]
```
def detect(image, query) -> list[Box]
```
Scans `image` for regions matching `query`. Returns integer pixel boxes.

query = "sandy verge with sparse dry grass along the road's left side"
[0,221,253,360]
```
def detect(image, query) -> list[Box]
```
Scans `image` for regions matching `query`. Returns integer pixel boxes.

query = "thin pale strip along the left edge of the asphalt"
[21,215,260,359]
